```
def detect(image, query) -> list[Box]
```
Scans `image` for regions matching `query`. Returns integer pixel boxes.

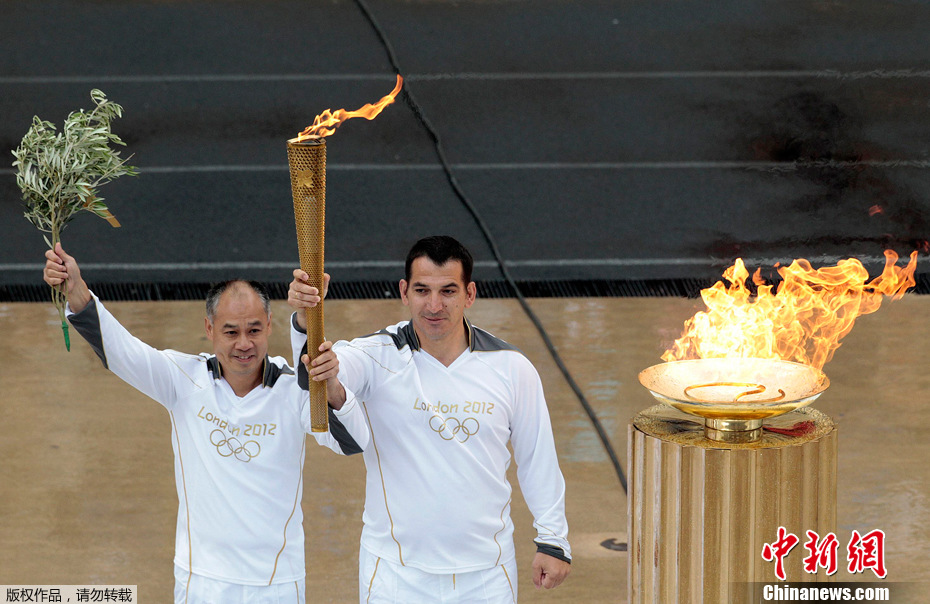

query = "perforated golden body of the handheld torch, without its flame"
[287,139,329,432]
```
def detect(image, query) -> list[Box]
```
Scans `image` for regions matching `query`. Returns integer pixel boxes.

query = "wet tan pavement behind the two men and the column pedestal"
[0,295,930,604]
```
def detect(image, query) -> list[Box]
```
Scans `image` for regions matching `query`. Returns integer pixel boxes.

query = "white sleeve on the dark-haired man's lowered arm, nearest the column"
[511,356,571,560]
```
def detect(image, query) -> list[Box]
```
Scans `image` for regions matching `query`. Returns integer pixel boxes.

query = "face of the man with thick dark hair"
[400,256,476,341]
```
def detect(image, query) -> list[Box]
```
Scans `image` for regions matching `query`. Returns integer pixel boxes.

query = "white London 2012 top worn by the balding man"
[68,296,369,585]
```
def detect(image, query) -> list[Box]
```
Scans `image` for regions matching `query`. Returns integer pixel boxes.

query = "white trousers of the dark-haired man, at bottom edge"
[358,548,517,604]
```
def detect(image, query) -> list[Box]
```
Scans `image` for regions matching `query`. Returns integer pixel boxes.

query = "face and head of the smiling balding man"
[205,283,271,379]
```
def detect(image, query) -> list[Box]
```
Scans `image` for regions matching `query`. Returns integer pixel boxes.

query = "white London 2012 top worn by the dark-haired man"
[292,320,571,573]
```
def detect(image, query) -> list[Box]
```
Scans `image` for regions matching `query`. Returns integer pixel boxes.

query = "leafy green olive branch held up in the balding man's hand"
[13,89,138,350]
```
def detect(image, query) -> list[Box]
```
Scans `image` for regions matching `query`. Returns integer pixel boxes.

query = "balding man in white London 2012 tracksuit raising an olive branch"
[44,243,370,604]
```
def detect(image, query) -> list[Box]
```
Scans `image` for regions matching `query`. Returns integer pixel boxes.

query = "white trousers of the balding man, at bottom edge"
[174,565,306,604]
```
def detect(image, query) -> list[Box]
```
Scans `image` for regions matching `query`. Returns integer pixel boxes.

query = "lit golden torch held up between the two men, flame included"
[287,75,403,432]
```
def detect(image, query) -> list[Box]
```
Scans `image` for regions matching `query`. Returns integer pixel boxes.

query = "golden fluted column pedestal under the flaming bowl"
[628,404,836,604]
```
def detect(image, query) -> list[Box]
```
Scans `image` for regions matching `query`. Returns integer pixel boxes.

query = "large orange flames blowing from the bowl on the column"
[662,250,917,370]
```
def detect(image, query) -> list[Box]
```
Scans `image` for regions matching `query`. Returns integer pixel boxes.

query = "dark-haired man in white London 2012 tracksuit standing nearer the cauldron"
[288,236,571,604]
